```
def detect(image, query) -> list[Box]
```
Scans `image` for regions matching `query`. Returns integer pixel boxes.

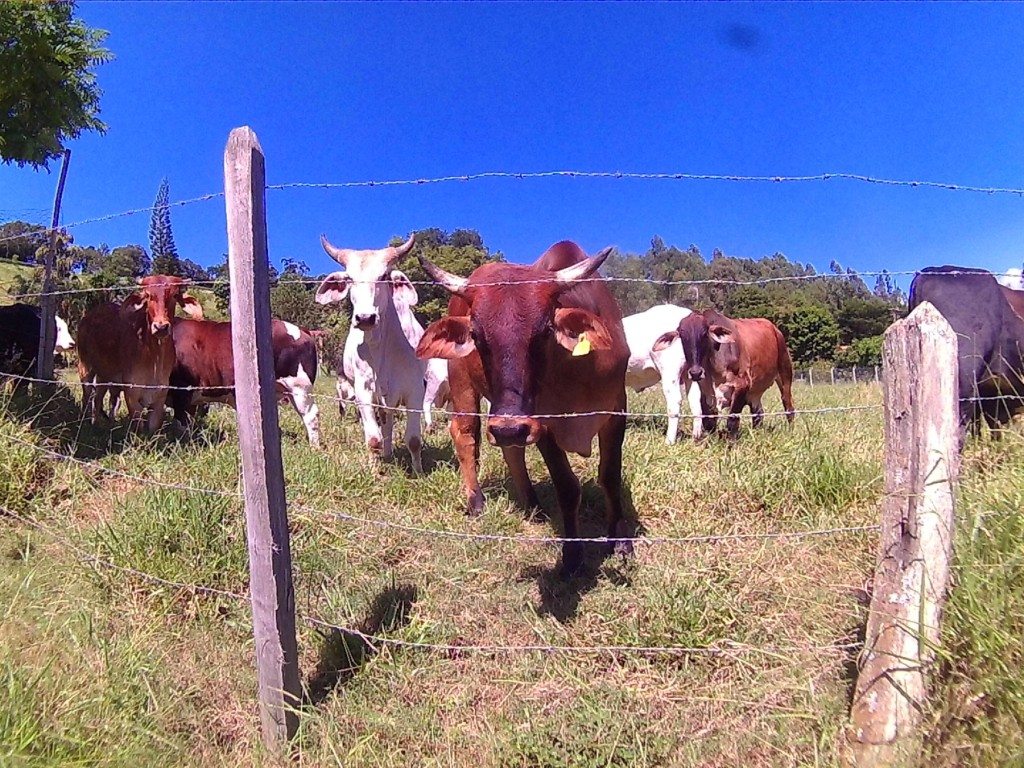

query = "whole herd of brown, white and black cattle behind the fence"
[0,237,1024,572]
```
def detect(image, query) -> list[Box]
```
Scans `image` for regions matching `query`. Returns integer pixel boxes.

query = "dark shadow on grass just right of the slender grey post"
[303,584,418,707]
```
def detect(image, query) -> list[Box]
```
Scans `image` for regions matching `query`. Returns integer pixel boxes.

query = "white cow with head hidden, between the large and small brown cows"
[623,304,700,445]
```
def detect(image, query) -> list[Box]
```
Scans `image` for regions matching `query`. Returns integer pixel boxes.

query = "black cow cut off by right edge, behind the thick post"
[910,265,1024,434]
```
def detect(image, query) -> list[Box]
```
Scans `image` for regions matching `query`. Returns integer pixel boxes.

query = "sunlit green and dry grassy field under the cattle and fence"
[0,370,1024,768]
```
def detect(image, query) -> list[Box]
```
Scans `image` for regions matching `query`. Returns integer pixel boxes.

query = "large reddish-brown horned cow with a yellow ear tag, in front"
[416,241,632,574]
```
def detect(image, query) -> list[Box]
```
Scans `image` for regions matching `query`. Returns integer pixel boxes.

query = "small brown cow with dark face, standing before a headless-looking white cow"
[654,309,794,439]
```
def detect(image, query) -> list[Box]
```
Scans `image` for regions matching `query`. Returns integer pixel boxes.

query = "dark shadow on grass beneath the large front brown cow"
[520,479,645,624]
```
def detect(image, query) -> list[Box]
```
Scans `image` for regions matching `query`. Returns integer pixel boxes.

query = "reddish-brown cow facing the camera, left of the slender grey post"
[78,274,203,432]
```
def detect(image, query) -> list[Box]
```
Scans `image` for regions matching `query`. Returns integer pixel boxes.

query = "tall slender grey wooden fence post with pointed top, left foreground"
[224,127,300,755]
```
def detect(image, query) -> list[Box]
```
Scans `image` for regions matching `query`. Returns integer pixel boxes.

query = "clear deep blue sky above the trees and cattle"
[0,2,1024,284]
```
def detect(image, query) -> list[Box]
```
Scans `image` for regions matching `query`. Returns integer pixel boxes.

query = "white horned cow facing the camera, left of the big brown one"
[316,234,426,474]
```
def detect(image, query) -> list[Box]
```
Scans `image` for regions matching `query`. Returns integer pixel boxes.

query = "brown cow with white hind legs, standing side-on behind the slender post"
[170,317,319,447]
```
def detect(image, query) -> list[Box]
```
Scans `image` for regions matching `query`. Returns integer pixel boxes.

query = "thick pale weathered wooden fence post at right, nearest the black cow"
[848,302,959,766]
